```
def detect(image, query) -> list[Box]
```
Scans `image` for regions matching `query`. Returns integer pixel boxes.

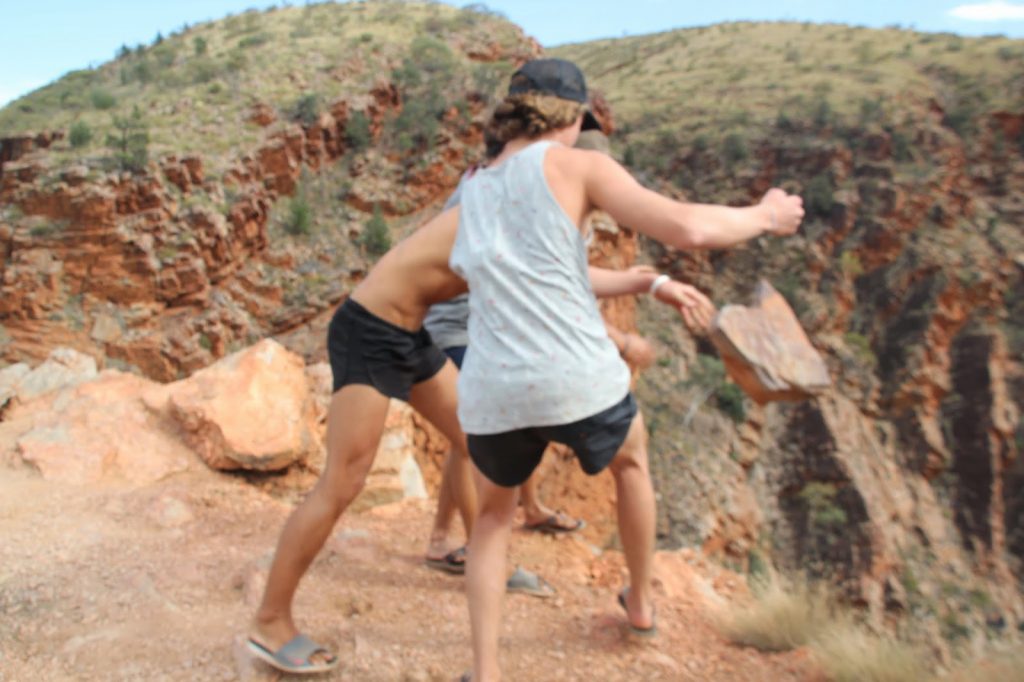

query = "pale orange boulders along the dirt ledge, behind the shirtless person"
[0,340,430,503]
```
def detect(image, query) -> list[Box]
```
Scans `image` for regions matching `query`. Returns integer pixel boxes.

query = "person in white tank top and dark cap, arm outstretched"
[458,59,804,682]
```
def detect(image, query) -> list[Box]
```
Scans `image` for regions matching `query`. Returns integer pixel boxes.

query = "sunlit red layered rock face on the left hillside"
[0,33,539,381]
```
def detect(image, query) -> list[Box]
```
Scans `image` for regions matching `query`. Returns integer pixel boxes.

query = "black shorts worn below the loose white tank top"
[467,393,637,487]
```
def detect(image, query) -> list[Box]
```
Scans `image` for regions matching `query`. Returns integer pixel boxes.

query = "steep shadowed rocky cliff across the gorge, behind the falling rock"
[641,100,1024,646]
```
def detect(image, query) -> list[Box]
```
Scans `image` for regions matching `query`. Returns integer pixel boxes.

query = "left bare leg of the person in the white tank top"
[466,471,517,682]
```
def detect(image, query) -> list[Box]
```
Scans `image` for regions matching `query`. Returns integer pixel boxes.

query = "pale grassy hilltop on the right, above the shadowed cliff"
[550,23,1024,160]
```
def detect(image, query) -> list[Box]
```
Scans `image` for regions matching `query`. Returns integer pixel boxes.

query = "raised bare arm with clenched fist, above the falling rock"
[572,150,804,249]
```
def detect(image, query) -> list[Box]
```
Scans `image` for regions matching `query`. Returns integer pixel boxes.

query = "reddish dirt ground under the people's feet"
[0,468,813,682]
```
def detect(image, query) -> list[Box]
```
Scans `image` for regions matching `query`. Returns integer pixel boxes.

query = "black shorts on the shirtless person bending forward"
[327,298,447,400]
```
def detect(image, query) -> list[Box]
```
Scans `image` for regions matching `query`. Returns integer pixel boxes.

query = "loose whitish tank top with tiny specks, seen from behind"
[450,142,630,434]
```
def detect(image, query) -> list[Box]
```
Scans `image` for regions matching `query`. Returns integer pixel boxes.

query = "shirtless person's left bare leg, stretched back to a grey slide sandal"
[252,384,388,650]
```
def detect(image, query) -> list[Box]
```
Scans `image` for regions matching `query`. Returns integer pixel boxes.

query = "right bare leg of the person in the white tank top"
[609,413,655,628]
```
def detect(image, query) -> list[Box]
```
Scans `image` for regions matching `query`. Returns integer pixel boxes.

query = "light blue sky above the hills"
[0,0,1024,109]
